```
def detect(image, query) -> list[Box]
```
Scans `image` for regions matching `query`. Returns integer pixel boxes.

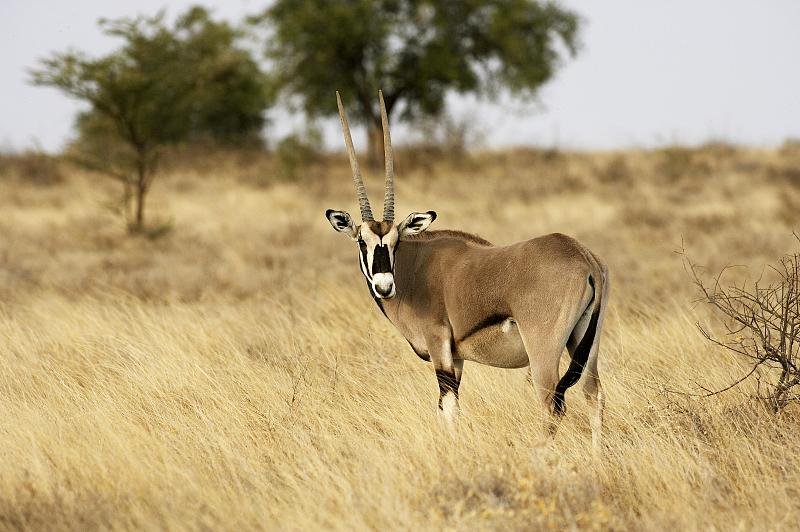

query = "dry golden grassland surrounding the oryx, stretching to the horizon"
[0,144,800,530]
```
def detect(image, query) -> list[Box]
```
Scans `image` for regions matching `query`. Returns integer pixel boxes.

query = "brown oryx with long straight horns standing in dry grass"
[325,92,609,448]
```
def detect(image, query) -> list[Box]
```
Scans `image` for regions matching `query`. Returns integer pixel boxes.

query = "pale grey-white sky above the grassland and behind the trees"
[0,0,800,150]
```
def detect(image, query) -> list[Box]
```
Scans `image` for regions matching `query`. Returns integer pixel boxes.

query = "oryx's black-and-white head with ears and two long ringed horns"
[325,91,436,299]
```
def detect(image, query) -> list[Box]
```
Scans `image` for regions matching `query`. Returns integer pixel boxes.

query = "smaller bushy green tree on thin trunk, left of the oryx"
[31,7,269,231]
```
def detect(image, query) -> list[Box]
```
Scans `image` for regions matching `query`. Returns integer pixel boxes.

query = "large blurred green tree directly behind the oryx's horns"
[260,0,579,163]
